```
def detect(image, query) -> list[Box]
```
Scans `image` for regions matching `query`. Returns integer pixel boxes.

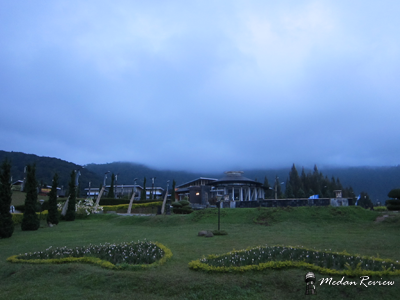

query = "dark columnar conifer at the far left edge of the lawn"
[0,159,14,238]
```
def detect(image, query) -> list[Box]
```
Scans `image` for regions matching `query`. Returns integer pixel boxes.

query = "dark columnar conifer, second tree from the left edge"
[21,165,40,231]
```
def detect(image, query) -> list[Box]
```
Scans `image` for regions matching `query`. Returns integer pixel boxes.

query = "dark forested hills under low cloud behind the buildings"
[0,150,400,202]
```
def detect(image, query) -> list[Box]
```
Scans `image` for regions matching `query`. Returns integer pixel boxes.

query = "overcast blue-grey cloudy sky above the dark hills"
[0,0,400,171]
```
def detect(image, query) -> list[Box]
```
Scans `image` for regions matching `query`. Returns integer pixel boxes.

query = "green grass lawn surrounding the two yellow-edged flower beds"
[0,207,400,299]
